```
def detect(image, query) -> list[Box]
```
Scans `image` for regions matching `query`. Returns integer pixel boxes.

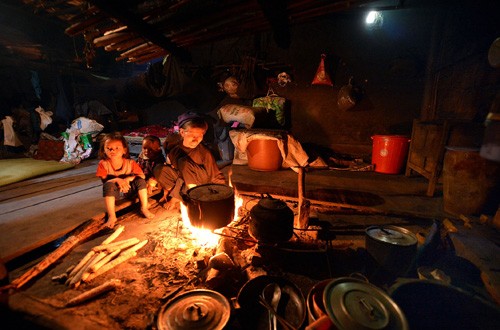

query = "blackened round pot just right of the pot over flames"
[248,194,294,243]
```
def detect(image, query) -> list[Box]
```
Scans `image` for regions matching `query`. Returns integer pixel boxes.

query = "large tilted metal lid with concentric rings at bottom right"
[323,278,408,330]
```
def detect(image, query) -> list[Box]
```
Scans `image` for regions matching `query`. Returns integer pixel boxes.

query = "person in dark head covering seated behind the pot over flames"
[154,112,226,209]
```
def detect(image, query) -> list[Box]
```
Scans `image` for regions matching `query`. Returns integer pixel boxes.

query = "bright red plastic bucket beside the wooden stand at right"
[372,135,410,174]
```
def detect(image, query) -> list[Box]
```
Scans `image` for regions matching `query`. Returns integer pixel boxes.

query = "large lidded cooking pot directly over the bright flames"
[184,183,234,230]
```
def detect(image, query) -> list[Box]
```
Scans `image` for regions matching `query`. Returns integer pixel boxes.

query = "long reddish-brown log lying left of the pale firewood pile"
[11,218,105,290]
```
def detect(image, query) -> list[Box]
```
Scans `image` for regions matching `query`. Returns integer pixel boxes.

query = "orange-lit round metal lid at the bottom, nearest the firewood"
[157,289,231,330]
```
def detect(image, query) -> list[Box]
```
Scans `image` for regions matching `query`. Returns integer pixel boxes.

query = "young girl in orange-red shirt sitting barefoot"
[96,133,154,228]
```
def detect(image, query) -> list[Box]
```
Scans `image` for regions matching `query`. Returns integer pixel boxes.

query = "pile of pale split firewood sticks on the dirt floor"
[52,226,148,288]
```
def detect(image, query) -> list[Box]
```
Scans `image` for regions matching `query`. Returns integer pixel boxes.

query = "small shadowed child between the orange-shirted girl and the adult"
[137,135,165,194]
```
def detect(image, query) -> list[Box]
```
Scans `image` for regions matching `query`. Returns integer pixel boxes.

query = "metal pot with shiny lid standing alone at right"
[365,225,417,276]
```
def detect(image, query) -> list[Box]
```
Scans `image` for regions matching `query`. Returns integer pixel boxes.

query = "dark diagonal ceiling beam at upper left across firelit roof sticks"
[90,0,191,60]
